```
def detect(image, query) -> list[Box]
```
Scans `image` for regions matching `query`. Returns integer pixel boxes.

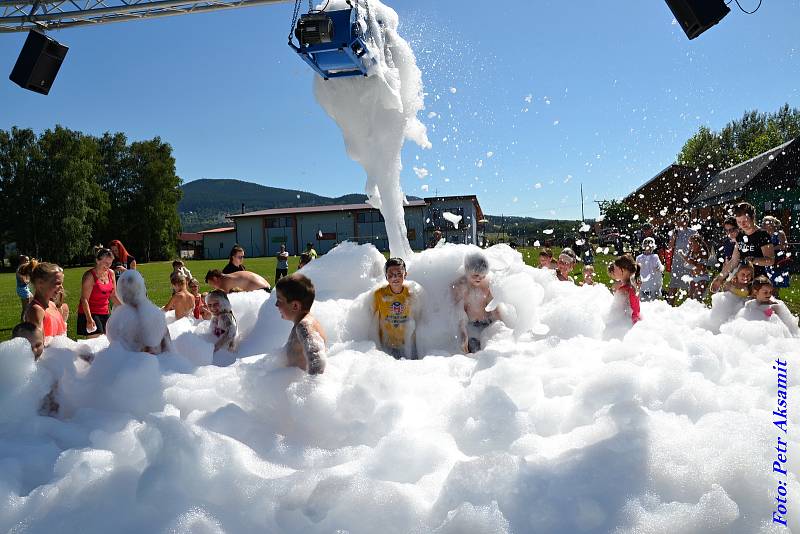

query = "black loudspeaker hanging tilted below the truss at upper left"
[8,30,69,95]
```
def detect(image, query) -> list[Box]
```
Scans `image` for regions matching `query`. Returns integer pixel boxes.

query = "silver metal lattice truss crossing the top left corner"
[0,0,293,33]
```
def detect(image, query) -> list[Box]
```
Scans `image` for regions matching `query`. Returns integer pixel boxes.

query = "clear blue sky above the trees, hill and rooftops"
[0,0,800,219]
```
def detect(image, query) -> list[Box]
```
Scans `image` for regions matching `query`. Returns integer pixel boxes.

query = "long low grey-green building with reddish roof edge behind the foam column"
[212,195,483,259]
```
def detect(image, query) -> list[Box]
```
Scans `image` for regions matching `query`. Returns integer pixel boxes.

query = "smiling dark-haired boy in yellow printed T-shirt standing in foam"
[372,258,421,360]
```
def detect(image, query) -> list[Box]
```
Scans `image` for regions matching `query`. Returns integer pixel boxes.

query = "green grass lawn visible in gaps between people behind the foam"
[0,248,800,341]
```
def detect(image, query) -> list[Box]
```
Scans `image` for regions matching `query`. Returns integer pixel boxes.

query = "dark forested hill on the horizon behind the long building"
[178,179,367,232]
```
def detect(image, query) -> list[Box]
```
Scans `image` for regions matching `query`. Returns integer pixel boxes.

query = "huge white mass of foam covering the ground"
[0,244,800,534]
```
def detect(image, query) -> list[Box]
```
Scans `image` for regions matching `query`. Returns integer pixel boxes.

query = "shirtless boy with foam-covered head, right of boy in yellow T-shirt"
[453,252,500,354]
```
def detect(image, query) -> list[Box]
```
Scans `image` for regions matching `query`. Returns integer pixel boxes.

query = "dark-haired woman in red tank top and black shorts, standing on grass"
[77,248,120,337]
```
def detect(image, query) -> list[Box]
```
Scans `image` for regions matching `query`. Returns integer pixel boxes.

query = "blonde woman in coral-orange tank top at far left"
[23,260,67,341]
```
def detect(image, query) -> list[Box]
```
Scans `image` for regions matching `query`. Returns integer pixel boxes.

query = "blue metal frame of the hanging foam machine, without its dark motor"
[289,9,374,80]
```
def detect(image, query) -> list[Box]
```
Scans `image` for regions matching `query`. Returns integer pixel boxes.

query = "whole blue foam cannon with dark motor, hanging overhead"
[289,7,374,80]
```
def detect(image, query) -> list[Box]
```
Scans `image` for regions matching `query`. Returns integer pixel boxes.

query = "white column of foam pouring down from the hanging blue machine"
[314,0,430,258]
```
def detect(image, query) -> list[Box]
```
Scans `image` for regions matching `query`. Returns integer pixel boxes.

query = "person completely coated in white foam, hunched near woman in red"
[106,269,172,354]
